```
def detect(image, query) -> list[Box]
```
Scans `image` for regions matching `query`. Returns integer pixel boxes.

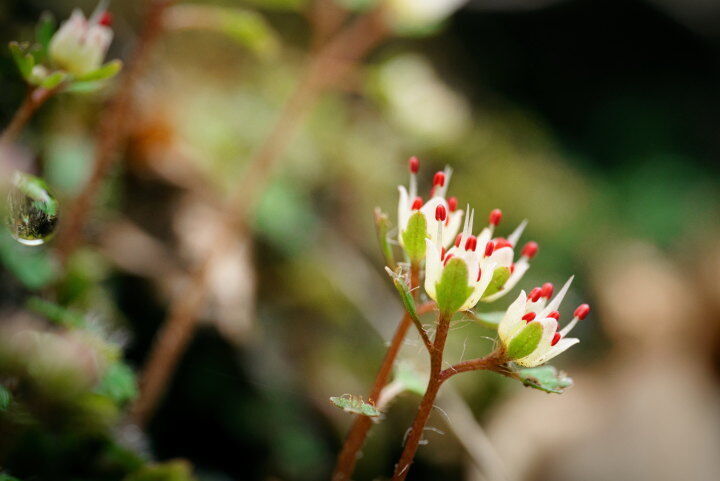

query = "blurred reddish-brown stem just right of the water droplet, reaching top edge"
[57,0,175,260]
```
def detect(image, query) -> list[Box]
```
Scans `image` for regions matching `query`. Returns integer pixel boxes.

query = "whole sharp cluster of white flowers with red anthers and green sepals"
[398,157,590,367]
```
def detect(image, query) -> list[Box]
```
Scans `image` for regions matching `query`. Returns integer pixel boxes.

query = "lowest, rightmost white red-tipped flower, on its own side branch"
[498,277,590,367]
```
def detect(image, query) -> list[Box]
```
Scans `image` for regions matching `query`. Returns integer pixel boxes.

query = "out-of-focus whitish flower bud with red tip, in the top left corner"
[48,4,113,76]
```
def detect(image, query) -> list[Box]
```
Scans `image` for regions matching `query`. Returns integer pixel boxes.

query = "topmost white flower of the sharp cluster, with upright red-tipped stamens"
[398,157,463,247]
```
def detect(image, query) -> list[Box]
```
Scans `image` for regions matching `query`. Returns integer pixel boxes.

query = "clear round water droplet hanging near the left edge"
[7,172,59,246]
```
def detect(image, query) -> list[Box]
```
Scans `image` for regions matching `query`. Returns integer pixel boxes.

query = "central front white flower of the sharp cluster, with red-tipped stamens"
[425,206,513,311]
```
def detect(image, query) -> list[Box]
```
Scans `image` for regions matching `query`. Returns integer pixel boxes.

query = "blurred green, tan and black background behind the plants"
[0,0,720,481]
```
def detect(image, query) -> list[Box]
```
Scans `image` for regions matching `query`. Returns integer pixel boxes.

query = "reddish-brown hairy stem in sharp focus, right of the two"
[392,314,452,481]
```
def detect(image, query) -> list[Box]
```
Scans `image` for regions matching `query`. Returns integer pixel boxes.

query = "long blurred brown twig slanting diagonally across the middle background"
[132,2,387,426]
